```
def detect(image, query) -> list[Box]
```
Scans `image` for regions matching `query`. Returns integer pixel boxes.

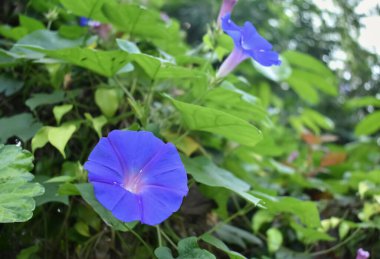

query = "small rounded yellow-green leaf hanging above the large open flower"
[95,87,120,117]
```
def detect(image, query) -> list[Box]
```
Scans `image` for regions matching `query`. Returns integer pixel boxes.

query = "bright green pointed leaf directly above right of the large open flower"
[170,98,262,146]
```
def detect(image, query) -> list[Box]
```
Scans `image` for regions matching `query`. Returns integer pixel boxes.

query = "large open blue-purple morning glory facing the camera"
[84,130,188,225]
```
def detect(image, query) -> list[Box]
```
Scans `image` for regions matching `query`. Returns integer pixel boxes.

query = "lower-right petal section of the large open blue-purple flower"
[141,187,183,225]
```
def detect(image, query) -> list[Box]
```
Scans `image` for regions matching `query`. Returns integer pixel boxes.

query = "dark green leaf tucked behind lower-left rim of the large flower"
[75,183,137,231]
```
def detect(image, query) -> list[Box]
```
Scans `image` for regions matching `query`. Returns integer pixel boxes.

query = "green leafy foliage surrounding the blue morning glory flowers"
[0,0,380,258]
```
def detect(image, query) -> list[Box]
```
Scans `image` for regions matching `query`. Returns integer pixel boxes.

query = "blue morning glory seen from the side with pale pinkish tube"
[216,13,281,78]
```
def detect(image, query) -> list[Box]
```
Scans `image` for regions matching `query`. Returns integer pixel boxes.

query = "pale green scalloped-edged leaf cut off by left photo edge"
[0,145,44,223]
